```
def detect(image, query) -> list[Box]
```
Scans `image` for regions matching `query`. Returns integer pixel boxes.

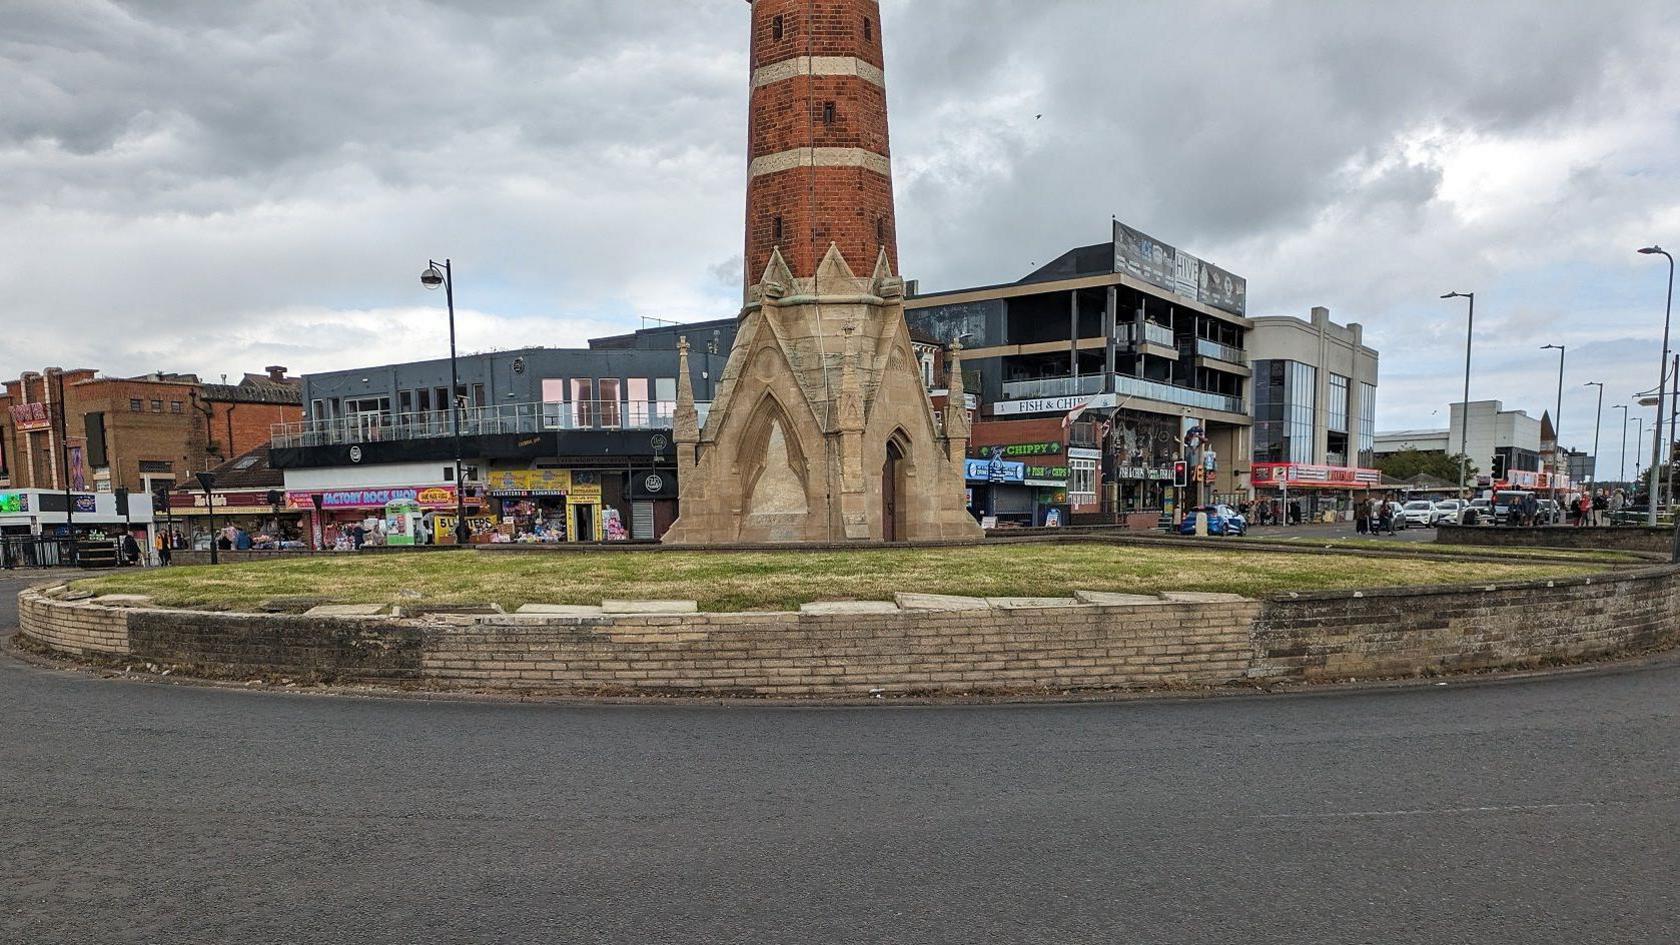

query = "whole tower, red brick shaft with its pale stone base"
[665,0,979,545]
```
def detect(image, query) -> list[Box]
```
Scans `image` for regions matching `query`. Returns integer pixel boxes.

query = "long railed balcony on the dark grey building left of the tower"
[270,400,711,449]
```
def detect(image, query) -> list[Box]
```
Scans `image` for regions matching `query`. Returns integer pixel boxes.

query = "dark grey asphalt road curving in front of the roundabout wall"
[0,564,1680,945]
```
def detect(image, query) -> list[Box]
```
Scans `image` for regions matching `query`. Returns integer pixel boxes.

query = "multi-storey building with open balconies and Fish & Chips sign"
[906,224,1253,525]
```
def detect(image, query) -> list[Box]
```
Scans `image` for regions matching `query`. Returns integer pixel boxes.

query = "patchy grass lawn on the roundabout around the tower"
[76,543,1603,610]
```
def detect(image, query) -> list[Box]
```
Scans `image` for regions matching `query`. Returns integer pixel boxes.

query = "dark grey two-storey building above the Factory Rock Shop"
[269,319,736,545]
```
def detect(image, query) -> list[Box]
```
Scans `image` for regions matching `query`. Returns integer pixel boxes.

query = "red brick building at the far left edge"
[0,359,302,493]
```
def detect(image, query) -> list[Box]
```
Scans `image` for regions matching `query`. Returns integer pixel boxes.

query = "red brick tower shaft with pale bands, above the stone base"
[746,0,899,286]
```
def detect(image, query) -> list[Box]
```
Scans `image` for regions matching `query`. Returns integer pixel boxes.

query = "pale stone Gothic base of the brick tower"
[664,240,981,545]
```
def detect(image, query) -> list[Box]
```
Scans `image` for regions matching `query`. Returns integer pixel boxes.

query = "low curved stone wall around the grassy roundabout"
[18,567,1680,698]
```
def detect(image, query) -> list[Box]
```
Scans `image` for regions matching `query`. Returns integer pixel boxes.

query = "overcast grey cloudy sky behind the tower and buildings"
[0,0,1680,462]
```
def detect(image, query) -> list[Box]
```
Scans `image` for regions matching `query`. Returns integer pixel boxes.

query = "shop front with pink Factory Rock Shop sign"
[286,484,463,550]
